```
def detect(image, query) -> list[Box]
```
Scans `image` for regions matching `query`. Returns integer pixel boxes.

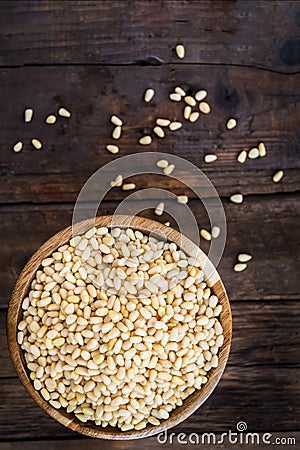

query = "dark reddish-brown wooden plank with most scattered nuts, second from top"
[0,64,300,203]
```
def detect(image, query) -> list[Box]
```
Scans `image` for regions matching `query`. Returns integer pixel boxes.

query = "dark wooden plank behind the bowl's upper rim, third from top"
[0,194,300,306]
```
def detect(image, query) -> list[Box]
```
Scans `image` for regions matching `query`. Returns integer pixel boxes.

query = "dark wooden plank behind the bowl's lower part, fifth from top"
[0,365,300,440]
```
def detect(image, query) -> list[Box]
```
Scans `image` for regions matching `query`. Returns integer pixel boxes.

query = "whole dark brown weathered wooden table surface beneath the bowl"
[0,0,300,450]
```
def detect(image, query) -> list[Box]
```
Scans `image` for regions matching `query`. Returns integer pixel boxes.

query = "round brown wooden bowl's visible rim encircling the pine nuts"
[7,216,232,439]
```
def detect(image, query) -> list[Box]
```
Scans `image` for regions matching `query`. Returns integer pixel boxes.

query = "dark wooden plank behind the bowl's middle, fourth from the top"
[0,301,300,378]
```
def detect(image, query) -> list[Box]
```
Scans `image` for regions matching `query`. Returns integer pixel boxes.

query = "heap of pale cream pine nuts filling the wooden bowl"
[17,227,224,431]
